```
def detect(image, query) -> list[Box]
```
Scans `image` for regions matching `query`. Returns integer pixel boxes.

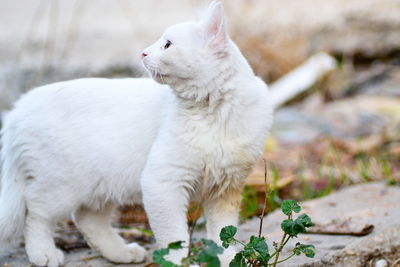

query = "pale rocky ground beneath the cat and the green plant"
[0,183,400,267]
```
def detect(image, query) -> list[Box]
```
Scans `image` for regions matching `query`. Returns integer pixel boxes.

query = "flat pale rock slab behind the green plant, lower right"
[239,183,400,267]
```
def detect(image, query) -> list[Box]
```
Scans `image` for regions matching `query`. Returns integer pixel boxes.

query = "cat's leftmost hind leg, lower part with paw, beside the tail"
[24,213,64,267]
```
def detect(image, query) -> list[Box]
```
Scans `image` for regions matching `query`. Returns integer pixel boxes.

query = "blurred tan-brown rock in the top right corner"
[310,8,400,61]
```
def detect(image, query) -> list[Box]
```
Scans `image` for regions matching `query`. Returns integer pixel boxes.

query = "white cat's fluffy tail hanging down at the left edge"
[0,123,26,252]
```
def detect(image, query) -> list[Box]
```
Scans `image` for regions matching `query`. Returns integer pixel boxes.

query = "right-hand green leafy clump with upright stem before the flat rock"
[220,200,315,267]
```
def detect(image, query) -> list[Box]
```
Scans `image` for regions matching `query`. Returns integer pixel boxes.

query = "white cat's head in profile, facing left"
[142,1,232,90]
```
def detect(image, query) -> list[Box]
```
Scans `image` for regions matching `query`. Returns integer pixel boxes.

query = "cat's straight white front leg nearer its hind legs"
[141,163,191,264]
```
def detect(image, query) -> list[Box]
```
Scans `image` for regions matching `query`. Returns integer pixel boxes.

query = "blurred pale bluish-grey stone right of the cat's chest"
[272,95,400,143]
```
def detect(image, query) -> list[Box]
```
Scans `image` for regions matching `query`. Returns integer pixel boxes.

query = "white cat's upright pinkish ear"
[203,1,228,46]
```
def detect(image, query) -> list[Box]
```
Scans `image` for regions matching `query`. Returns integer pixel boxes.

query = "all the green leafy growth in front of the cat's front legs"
[153,200,315,267]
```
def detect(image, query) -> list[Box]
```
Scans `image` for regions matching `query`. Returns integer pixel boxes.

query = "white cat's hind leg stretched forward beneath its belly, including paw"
[74,204,146,263]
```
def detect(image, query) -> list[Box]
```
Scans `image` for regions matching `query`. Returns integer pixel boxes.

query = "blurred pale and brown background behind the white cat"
[0,0,400,217]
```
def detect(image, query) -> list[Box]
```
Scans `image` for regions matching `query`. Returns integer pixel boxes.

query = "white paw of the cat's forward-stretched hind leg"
[106,243,146,263]
